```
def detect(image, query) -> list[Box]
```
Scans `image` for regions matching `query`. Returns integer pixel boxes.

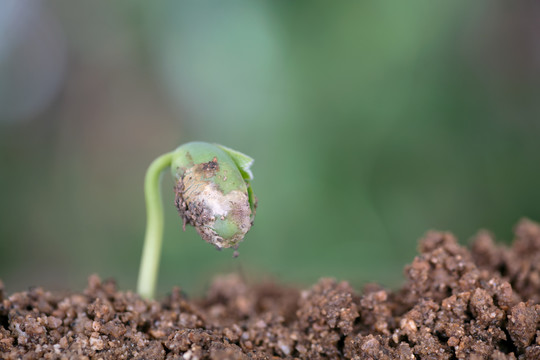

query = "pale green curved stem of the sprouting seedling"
[137,152,173,299]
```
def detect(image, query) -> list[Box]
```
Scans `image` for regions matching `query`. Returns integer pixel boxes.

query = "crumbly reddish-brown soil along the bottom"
[0,220,540,360]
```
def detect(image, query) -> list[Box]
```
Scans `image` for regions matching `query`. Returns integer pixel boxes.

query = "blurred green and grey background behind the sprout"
[0,0,540,294]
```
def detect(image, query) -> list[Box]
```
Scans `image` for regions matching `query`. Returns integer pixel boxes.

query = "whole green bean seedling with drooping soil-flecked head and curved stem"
[137,142,257,299]
